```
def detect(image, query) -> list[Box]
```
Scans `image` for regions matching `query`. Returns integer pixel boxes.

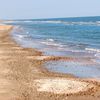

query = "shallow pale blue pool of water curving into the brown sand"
[44,61,100,78]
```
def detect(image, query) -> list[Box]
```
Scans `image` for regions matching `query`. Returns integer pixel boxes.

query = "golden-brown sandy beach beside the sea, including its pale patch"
[0,25,100,100]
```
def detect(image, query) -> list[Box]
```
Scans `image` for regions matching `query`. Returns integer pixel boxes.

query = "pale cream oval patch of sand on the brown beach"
[35,78,94,94]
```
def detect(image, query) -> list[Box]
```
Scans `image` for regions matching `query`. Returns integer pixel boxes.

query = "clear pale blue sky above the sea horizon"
[0,0,100,19]
